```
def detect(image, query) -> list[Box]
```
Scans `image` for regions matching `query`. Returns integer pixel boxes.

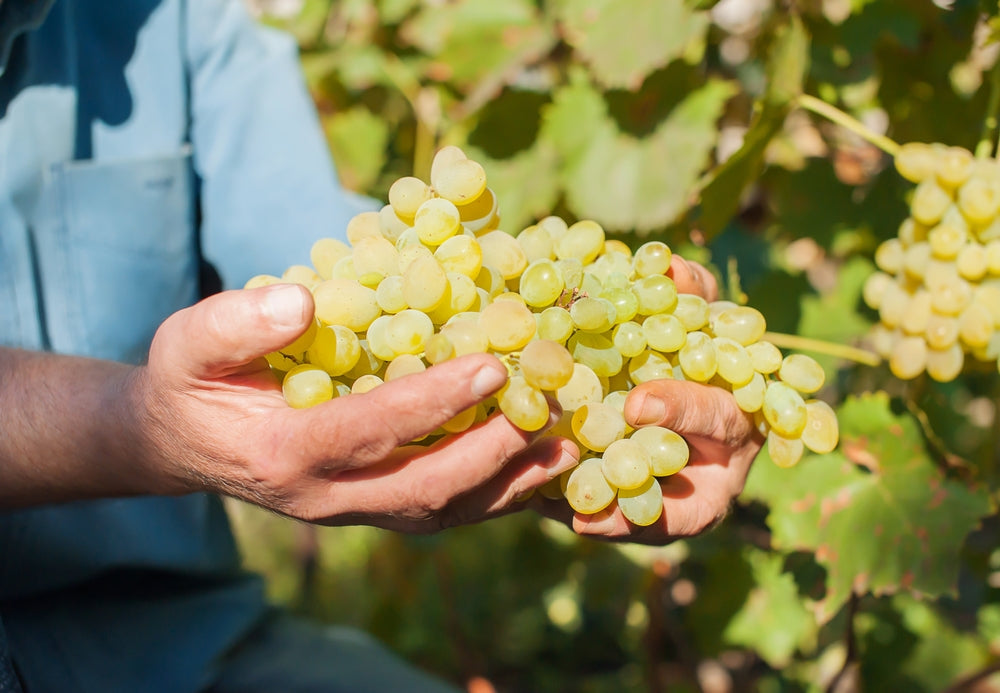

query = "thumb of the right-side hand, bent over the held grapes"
[625,379,746,437]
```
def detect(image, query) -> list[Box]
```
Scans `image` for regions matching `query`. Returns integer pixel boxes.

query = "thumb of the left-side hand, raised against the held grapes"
[150,284,313,378]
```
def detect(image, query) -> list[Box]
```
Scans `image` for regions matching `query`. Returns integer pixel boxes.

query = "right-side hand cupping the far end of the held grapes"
[529,255,764,544]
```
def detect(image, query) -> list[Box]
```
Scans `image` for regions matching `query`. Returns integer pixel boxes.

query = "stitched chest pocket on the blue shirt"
[47,148,199,363]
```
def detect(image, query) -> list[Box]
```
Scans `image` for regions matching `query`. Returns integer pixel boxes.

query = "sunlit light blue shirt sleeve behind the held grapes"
[185,0,378,288]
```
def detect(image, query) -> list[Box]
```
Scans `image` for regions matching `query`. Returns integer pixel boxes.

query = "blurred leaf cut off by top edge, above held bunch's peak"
[401,0,556,89]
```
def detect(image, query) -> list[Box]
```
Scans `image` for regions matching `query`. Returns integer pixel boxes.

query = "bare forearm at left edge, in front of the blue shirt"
[0,348,154,508]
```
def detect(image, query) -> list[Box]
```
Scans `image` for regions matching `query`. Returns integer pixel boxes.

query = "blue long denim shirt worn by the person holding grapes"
[0,0,366,693]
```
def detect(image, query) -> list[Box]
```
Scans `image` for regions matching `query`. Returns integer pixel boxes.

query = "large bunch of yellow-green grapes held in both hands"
[247,147,839,525]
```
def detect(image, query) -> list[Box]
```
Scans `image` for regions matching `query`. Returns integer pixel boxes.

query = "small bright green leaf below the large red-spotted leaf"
[724,549,817,669]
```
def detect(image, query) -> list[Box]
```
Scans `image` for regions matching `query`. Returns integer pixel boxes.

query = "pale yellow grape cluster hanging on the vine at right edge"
[863,143,1000,382]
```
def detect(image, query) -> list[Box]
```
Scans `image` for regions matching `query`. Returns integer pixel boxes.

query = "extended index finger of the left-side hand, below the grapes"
[289,354,512,468]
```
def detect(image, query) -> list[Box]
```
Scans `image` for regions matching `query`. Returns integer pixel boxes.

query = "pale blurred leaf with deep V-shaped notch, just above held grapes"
[540,75,734,234]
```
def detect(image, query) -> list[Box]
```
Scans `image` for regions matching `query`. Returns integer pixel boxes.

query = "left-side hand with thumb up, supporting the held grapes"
[129,285,579,532]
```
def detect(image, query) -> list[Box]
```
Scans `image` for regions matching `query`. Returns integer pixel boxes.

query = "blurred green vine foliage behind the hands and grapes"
[233,0,1000,693]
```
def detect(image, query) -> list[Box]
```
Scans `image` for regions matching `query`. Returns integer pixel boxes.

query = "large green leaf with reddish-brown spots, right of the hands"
[746,393,991,620]
